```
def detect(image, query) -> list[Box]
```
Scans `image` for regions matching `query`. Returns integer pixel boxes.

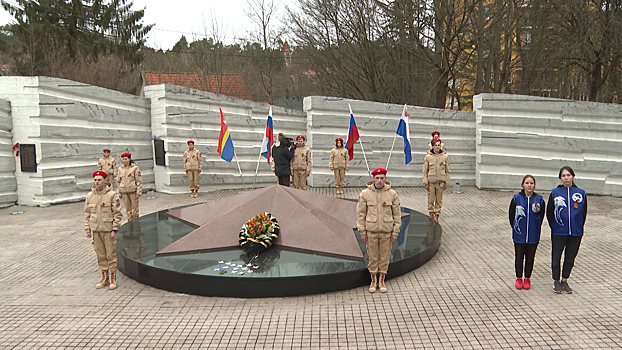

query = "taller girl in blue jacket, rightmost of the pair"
[546,166,587,294]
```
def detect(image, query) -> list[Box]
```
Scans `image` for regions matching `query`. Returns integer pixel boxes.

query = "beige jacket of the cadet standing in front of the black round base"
[356,181,402,236]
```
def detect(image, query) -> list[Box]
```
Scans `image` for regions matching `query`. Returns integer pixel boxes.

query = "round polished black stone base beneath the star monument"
[117,208,442,298]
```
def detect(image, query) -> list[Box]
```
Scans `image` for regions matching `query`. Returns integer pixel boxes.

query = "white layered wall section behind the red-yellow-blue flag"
[145,85,307,193]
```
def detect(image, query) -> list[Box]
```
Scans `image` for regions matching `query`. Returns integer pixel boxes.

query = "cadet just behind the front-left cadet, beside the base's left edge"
[117,153,143,221]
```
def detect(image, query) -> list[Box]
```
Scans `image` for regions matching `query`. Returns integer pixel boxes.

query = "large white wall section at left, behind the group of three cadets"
[0,77,154,205]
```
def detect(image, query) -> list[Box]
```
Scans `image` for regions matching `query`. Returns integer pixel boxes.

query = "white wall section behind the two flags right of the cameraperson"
[304,96,475,187]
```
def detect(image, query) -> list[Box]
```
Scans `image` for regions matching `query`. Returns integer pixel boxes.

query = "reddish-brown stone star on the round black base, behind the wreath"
[156,185,363,259]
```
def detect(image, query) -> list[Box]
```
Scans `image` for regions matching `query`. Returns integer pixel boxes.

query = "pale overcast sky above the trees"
[0,0,293,50]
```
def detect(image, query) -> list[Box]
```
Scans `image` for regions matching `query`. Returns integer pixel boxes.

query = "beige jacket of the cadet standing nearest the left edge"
[84,186,123,232]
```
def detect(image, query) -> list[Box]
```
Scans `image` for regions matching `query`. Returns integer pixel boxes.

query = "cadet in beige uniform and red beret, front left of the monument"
[84,170,123,289]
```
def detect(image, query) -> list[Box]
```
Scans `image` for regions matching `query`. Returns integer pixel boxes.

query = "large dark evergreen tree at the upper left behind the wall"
[0,0,152,75]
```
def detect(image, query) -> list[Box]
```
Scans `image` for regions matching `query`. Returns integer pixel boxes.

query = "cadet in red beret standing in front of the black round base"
[356,168,402,293]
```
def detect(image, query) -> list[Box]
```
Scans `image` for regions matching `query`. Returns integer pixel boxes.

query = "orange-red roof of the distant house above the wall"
[141,73,254,101]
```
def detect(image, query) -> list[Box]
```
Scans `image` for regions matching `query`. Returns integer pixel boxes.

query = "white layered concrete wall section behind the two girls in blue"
[474,94,622,196]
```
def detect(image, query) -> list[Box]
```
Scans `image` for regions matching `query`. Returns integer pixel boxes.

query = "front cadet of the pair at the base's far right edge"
[422,139,449,221]
